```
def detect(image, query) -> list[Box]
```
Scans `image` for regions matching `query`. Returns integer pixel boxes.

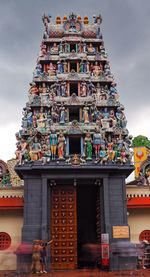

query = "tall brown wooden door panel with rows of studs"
[51,185,77,269]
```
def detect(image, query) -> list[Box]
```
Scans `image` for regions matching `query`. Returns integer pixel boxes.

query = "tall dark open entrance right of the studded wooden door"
[77,184,98,268]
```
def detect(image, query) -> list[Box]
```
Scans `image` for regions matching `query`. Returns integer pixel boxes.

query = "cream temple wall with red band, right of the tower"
[127,136,150,245]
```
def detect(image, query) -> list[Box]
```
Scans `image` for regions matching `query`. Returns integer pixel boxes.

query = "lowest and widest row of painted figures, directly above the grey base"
[15,127,132,165]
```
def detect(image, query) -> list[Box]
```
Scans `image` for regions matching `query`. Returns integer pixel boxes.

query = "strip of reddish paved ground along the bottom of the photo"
[0,269,150,277]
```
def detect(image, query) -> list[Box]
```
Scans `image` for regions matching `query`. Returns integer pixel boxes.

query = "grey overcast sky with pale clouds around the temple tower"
[0,0,150,166]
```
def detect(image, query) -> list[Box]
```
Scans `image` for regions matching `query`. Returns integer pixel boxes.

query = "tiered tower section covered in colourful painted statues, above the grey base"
[16,13,132,166]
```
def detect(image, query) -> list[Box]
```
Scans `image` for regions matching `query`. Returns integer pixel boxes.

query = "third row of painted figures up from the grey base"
[28,80,119,106]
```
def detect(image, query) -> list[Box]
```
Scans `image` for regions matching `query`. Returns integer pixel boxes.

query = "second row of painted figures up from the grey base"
[21,102,127,133]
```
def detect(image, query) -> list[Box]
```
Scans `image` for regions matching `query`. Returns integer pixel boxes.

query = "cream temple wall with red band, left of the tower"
[0,159,24,270]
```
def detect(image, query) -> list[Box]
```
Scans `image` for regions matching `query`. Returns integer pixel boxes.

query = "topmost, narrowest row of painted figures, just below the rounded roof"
[38,41,108,60]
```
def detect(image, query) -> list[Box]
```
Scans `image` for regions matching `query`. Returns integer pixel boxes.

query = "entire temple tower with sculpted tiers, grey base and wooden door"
[15,13,133,270]
